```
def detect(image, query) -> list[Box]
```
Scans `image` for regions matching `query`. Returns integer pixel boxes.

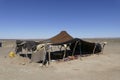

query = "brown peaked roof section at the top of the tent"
[49,31,73,44]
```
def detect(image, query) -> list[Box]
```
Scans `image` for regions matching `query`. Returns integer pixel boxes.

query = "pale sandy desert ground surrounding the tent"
[0,38,120,80]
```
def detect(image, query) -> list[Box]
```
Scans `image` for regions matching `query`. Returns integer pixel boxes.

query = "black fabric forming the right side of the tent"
[52,38,102,54]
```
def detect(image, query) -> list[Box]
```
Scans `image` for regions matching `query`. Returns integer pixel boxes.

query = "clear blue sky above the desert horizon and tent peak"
[0,0,120,39]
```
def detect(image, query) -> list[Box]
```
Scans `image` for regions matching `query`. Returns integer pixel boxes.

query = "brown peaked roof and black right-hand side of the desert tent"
[49,31,102,54]
